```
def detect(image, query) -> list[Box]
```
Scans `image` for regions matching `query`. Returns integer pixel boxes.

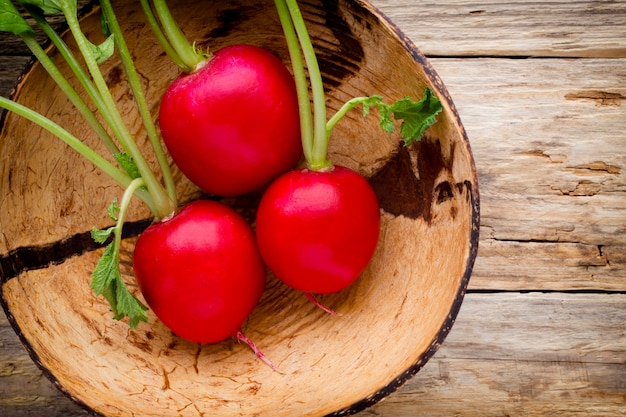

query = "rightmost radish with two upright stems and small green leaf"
[256,0,441,313]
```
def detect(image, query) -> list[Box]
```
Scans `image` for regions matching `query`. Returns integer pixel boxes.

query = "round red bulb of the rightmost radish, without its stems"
[256,165,380,294]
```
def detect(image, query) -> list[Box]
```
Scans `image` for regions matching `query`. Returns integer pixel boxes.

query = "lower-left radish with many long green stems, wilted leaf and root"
[0,0,274,369]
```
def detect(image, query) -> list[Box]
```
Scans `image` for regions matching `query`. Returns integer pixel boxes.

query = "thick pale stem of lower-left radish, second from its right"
[59,0,176,218]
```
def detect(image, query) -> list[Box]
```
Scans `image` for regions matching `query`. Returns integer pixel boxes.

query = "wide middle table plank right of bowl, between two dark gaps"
[431,59,626,291]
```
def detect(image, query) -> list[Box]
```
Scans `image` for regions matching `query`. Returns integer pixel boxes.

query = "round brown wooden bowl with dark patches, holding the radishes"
[0,0,479,417]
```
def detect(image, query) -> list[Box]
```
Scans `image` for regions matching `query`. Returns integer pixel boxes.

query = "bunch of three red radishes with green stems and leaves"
[0,0,441,369]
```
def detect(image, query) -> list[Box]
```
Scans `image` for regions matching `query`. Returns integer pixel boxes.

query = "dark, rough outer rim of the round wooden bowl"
[0,0,480,417]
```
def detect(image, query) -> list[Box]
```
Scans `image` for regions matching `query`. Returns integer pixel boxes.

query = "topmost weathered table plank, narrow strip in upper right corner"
[372,0,626,58]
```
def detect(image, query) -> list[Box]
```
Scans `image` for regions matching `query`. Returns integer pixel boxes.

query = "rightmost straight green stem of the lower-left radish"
[100,0,177,205]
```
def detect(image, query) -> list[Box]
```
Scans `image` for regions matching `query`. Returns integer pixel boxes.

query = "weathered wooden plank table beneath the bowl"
[0,0,626,417]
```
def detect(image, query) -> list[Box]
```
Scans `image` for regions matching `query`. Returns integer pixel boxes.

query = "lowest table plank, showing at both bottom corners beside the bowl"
[0,293,626,417]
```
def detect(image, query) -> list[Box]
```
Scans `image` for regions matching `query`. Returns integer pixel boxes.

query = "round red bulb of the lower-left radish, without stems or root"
[133,200,265,343]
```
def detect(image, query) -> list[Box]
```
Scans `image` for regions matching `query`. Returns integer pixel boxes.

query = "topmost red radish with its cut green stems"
[142,0,302,197]
